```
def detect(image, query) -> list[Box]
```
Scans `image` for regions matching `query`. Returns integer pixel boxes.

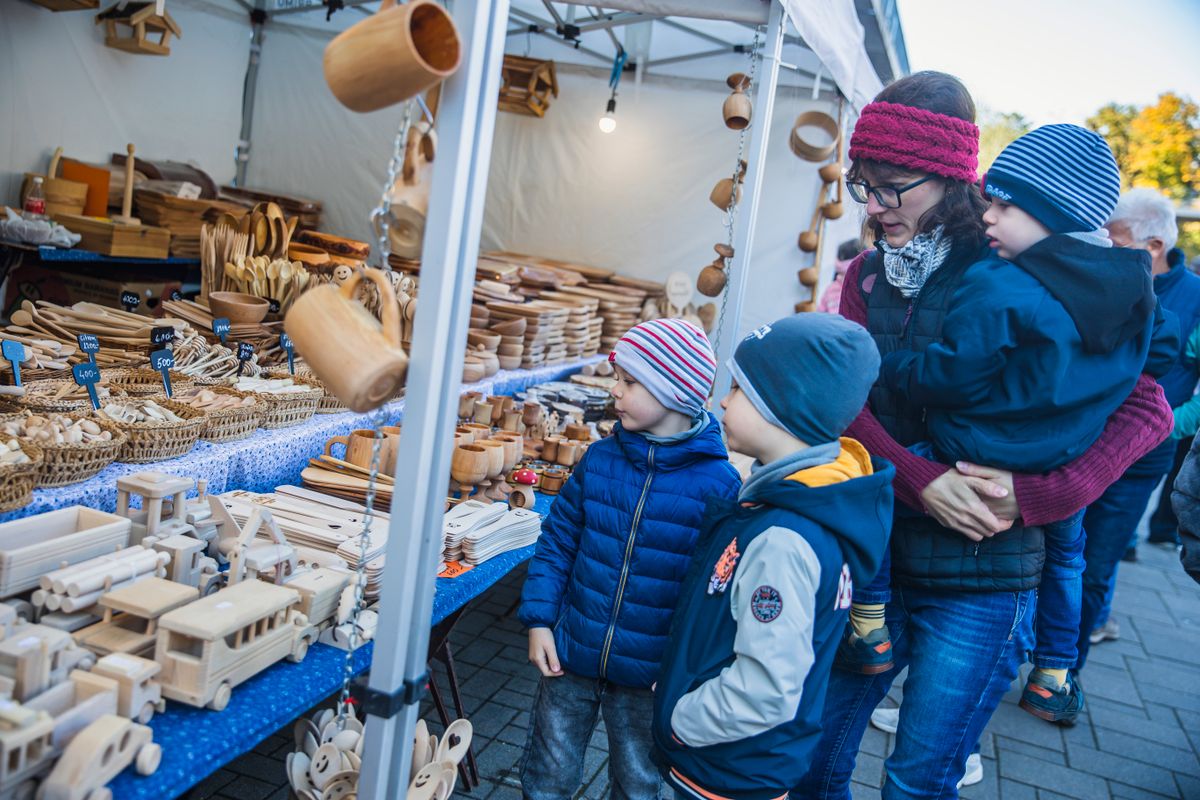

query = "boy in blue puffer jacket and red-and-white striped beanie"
[520,319,740,800]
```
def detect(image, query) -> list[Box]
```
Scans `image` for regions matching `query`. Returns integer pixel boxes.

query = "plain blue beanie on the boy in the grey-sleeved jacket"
[728,312,880,445]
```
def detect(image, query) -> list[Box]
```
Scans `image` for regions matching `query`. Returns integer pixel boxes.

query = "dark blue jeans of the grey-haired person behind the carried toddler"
[1075,474,1163,669]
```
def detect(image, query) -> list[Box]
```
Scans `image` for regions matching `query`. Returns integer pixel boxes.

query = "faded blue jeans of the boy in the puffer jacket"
[521,672,661,800]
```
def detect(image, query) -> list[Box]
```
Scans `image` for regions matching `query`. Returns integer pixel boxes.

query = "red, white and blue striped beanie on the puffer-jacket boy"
[608,319,716,417]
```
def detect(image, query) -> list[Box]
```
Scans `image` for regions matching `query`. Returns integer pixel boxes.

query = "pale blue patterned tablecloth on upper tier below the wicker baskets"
[0,356,599,522]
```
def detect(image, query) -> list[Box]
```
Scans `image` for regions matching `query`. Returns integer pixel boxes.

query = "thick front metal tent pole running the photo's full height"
[359,0,509,800]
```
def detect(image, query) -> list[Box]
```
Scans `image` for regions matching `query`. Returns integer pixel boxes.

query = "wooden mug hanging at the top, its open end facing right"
[325,0,462,112]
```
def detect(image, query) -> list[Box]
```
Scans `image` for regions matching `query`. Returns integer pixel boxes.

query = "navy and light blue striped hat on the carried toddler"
[984,125,1121,234]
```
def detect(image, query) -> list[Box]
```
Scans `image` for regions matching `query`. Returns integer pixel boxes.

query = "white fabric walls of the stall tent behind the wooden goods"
[0,0,865,338]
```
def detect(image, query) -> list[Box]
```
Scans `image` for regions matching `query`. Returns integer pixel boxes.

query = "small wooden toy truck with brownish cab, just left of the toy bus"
[74,578,199,658]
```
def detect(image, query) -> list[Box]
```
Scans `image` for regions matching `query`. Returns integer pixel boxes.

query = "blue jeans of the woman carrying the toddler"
[792,587,1036,800]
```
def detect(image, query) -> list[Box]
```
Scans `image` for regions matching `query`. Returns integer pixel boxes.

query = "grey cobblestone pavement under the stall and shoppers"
[188,532,1200,800]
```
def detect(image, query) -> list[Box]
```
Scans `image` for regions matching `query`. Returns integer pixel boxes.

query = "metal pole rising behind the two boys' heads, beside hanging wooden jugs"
[713,0,787,416]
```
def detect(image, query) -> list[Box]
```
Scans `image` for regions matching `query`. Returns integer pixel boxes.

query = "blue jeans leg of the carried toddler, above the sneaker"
[1033,510,1085,669]
